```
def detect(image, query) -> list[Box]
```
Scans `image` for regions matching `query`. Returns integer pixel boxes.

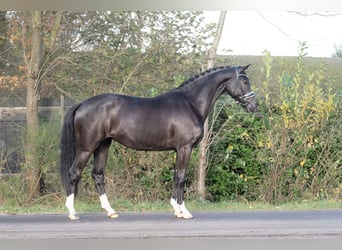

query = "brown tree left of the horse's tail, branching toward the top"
[12,11,62,201]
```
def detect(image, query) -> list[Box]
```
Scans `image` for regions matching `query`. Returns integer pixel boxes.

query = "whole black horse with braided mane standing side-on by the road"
[60,65,256,219]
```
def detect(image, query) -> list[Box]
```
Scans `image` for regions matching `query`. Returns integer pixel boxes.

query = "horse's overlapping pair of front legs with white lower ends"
[170,146,193,219]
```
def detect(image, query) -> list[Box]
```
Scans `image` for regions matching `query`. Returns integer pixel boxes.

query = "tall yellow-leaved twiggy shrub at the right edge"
[259,43,341,202]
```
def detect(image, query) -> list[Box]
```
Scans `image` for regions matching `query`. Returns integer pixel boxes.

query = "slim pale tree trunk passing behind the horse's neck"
[197,11,226,200]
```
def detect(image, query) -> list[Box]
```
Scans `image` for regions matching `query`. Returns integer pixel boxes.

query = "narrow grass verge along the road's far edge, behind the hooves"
[0,199,342,214]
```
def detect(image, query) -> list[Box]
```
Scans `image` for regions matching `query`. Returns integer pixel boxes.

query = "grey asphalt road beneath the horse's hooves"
[0,210,342,239]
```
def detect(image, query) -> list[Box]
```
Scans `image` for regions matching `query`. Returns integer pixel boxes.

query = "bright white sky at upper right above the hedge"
[204,11,342,57]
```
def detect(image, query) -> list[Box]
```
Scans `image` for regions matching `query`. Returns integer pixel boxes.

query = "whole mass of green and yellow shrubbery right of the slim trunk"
[207,43,342,203]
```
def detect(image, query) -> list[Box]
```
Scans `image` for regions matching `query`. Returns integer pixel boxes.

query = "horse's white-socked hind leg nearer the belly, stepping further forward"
[93,139,119,218]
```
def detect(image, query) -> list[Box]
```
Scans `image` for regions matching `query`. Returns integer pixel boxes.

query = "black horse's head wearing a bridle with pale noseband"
[226,64,257,113]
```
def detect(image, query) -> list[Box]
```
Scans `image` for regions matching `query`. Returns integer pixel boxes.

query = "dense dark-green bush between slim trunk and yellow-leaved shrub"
[206,107,263,201]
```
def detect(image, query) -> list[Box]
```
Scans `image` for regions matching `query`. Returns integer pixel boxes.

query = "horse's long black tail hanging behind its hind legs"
[60,104,80,195]
